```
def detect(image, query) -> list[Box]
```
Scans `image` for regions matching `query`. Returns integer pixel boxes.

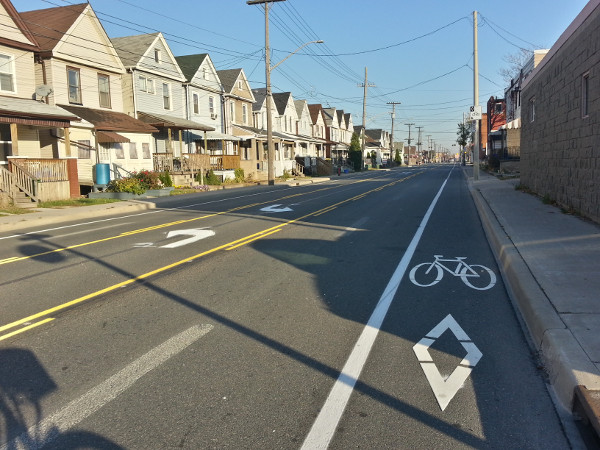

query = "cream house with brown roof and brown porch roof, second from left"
[19,3,156,192]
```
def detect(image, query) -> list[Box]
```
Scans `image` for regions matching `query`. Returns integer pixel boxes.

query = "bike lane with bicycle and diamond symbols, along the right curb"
[305,169,569,448]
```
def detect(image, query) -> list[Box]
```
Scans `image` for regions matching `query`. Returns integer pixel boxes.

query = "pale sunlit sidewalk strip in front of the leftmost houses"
[0,200,156,232]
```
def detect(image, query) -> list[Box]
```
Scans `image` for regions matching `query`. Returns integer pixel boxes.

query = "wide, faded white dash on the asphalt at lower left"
[0,325,213,450]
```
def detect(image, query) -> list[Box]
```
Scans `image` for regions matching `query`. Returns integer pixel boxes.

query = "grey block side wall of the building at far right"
[521,7,600,223]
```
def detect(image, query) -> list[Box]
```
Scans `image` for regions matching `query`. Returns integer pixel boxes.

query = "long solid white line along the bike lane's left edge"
[302,170,452,450]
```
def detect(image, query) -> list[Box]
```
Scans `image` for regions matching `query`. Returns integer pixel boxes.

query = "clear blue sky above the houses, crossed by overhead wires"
[12,0,587,153]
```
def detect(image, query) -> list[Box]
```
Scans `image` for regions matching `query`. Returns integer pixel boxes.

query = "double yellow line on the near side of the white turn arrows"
[0,173,418,340]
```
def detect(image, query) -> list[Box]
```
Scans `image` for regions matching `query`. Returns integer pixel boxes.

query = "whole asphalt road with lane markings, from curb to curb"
[0,165,569,449]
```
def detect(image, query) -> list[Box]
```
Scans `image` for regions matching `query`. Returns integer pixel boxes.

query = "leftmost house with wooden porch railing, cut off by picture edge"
[0,0,79,206]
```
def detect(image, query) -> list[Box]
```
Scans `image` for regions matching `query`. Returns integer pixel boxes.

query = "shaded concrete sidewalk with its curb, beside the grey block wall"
[463,166,600,428]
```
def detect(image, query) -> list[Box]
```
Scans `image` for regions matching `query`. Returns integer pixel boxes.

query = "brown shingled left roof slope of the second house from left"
[19,3,89,51]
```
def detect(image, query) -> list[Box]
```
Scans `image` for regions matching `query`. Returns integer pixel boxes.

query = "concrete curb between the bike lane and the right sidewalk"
[468,180,598,411]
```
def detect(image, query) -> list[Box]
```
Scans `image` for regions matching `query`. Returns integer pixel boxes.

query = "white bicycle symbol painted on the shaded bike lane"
[409,255,496,291]
